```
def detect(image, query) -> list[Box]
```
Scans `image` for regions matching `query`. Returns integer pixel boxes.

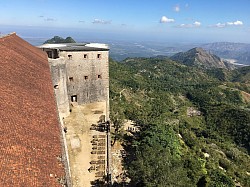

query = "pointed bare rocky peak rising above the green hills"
[171,48,227,69]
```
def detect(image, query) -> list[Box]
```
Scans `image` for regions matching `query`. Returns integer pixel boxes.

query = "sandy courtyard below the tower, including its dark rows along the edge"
[64,102,107,187]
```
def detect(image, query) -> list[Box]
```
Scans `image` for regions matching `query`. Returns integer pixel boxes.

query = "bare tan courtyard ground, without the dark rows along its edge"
[64,102,106,187]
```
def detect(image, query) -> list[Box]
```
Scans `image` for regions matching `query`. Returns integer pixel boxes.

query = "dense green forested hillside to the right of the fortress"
[110,58,250,187]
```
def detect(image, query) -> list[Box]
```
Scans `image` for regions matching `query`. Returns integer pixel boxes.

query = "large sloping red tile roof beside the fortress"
[0,34,65,187]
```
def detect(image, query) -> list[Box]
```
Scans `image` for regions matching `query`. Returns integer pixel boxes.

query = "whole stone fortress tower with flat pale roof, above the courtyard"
[39,43,109,118]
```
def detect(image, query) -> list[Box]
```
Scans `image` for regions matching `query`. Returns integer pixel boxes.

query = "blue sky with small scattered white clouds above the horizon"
[0,0,250,43]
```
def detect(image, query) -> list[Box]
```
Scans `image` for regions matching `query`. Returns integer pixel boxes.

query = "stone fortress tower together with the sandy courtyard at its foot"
[39,43,111,186]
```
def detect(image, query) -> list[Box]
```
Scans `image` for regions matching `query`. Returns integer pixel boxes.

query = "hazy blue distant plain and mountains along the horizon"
[25,37,250,65]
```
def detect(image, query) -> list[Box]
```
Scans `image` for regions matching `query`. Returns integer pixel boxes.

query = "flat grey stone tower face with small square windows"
[60,51,109,105]
